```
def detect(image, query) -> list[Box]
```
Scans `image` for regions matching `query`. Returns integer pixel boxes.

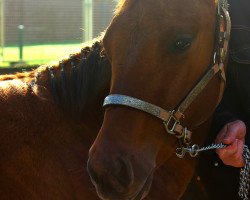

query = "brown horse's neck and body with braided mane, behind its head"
[0,42,111,200]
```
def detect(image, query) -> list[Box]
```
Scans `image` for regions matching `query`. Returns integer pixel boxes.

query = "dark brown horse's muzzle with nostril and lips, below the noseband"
[87,148,153,200]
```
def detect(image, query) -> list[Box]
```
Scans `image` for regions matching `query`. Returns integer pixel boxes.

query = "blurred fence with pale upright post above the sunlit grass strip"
[0,0,116,65]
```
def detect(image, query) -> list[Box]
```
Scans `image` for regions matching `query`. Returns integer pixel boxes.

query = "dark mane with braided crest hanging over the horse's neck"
[36,42,111,121]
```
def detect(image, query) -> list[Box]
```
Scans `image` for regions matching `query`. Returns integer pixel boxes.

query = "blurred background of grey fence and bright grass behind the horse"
[0,0,117,67]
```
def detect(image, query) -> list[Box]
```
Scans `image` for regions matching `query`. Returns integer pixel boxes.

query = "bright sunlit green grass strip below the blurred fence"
[0,44,83,67]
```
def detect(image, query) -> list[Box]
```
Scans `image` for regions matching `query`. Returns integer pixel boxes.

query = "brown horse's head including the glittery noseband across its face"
[88,0,230,200]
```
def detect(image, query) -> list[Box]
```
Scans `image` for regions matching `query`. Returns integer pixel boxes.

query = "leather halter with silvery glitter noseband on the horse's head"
[103,1,231,158]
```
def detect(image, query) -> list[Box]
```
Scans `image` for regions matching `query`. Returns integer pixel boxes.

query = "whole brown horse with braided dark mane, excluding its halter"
[0,0,230,200]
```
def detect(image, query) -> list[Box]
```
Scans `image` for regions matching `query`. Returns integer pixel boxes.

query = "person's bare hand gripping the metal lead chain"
[215,120,246,167]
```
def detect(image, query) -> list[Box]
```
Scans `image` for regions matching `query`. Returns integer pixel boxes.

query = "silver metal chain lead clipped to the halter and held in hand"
[176,144,250,200]
